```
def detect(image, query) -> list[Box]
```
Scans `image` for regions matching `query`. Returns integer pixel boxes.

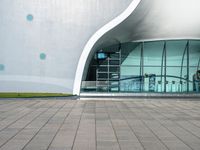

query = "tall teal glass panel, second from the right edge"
[166,41,187,92]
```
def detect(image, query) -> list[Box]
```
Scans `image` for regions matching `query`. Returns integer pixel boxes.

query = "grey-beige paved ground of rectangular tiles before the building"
[0,99,200,150]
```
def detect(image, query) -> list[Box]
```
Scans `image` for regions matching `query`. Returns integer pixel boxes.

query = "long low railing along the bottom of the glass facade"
[81,80,200,93]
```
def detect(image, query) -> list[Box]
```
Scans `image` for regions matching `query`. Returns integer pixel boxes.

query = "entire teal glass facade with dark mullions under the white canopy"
[81,40,200,93]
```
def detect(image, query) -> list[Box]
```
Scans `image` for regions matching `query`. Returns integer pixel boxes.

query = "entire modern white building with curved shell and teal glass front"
[0,0,200,95]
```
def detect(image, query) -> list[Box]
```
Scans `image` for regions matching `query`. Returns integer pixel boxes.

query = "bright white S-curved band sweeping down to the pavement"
[73,0,141,95]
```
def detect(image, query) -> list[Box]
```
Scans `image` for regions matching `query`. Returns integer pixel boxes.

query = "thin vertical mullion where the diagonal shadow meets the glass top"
[140,42,144,92]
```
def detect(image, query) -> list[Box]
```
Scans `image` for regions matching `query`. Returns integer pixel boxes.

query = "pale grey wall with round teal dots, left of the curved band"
[0,0,132,93]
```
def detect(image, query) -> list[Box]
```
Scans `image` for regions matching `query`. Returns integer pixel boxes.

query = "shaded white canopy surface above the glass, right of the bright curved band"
[75,0,200,93]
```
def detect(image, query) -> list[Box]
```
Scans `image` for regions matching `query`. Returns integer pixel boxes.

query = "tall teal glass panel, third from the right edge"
[143,41,164,92]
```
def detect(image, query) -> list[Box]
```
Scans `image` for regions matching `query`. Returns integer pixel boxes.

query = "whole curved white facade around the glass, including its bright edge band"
[0,0,200,94]
